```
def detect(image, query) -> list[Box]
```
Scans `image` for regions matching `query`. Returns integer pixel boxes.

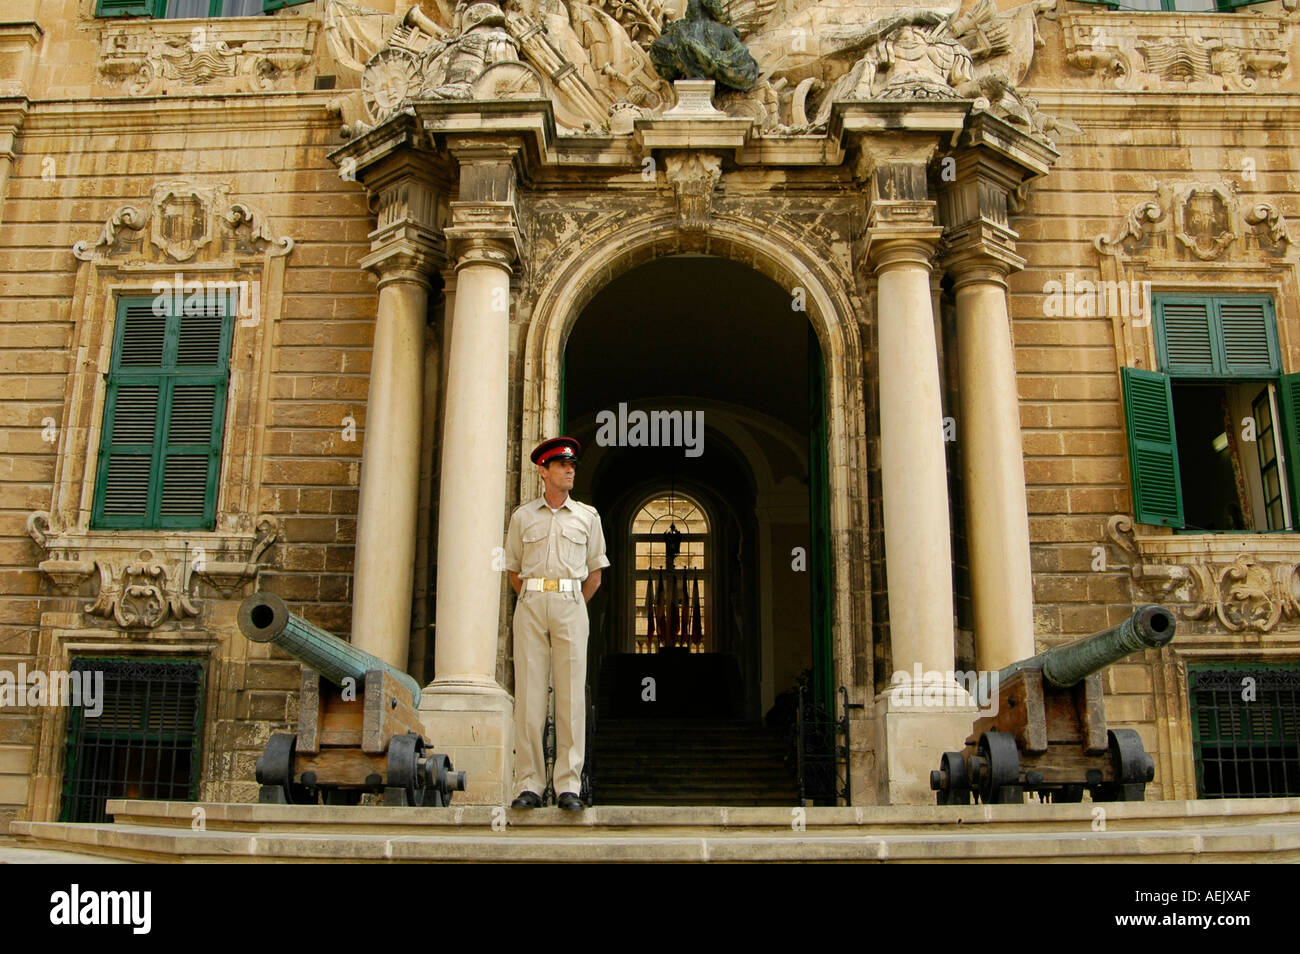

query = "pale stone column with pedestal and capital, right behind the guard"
[420,138,519,805]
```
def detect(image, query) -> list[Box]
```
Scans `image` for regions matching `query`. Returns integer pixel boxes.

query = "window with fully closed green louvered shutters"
[91,294,235,530]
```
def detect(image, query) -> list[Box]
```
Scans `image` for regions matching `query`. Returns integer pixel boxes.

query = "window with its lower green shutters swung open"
[1121,295,1300,533]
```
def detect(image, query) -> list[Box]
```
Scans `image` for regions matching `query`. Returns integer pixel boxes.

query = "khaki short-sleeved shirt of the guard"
[506,496,610,580]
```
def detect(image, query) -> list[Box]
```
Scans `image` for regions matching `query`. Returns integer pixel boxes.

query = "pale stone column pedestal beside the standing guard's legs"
[420,681,515,806]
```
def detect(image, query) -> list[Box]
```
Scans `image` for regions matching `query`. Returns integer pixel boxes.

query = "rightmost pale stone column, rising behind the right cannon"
[950,259,1034,669]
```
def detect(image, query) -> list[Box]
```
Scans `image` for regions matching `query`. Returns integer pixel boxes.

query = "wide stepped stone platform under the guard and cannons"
[10,798,1300,863]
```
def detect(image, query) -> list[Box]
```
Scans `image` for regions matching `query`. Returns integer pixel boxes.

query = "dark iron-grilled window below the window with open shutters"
[1187,663,1300,798]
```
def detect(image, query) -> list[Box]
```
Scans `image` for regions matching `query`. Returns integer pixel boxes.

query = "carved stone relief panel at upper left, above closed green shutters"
[99,17,320,96]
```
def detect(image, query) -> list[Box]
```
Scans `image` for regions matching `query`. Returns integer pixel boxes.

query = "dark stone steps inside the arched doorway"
[590,719,798,807]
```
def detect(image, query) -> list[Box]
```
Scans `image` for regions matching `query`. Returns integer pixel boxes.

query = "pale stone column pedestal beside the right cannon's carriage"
[875,681,979,805]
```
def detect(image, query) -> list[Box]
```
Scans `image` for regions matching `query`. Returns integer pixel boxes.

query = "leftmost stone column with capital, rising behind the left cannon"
[352,174,442,671]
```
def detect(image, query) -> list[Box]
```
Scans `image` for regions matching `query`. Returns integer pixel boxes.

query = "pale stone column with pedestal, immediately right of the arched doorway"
[868,161,975,805]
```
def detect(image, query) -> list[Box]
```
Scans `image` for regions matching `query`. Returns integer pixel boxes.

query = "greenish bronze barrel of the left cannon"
[239,593,420,708]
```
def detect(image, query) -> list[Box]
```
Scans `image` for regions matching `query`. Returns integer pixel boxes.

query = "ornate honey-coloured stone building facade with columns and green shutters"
[0,0,1300,827]
